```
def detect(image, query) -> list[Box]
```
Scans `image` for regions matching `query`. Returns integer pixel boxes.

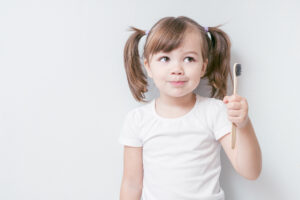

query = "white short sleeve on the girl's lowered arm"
[118,110,143,147]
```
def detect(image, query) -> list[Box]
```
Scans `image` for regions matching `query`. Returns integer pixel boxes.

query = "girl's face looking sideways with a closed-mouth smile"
[144,29,207,97]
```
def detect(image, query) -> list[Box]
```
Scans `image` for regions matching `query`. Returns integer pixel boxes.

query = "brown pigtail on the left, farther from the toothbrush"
[124,26,148,102]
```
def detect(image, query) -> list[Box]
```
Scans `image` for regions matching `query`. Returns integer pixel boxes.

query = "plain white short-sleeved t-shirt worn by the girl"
[119,94,232,200]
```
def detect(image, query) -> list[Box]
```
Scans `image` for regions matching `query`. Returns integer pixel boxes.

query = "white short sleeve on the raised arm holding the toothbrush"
[212,99,232,140]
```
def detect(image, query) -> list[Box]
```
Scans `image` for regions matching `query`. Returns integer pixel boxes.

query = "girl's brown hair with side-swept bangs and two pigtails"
[124,16,232,102]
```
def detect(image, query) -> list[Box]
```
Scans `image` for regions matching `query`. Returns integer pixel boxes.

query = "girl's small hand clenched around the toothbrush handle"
[223,95,249,128]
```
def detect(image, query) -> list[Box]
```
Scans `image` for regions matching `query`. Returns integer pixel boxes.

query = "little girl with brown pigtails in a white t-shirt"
[119,16,262,200]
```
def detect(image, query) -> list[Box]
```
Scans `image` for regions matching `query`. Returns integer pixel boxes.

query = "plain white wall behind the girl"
[0,0,300,200]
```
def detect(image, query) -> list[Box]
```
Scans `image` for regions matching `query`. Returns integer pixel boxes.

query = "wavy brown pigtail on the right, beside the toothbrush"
[205,26,233,99]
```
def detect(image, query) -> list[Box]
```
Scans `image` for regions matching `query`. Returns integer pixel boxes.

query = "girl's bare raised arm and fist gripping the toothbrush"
[220,95,262,180]
